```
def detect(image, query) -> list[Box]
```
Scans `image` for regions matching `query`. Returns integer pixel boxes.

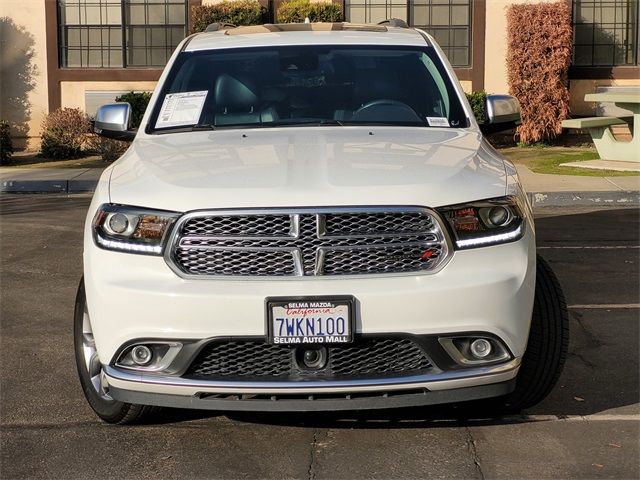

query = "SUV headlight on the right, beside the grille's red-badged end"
[438,195,525,249]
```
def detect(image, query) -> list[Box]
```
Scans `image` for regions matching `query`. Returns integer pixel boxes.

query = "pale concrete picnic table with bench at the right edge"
[562,90,640,162]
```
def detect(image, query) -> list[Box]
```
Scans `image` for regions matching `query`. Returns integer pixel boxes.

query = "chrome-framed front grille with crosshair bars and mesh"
[167,207,450,277]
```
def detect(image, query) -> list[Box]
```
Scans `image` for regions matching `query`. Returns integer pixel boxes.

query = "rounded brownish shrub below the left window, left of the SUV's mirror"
[40,108,90,160]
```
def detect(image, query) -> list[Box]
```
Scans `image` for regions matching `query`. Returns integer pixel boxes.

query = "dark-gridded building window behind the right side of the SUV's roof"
[345,0,473,67]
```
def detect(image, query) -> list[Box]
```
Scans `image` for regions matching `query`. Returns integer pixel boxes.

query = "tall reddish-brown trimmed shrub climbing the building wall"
[507,2,573,144]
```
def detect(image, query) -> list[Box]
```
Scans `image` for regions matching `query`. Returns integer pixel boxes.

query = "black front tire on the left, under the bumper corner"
[73,279,157,425]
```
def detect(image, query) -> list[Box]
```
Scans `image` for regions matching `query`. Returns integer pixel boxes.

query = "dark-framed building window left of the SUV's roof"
[58,0,187,68]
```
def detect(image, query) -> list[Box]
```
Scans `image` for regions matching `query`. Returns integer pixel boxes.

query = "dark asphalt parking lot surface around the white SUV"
[0,195,640,479]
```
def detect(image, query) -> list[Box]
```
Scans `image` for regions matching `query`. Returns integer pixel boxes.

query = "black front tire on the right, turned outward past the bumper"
[504,255,569,412]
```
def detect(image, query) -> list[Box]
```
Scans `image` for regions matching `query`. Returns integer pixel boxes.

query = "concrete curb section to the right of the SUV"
[527,190,640,208]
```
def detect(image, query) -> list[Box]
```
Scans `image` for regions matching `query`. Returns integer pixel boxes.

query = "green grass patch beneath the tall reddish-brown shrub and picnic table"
[499,146,640,177]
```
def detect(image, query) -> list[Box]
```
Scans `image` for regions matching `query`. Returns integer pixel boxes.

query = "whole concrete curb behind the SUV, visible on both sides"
[0,180,640,208]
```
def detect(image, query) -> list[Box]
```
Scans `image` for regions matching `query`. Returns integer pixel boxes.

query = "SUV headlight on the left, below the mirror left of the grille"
[93,204,179,255]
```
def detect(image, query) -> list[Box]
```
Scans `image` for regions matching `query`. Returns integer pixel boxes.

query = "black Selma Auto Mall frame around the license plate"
[265,295,356,346]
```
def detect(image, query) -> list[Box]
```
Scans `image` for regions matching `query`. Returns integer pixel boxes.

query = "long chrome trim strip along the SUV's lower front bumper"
[104,358,521,394]
